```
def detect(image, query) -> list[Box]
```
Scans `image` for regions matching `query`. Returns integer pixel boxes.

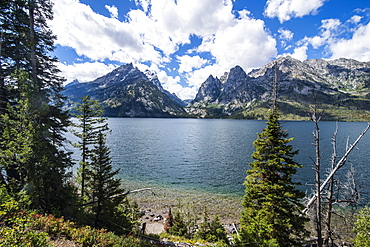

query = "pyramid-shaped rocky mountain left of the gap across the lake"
[64,64,186,117]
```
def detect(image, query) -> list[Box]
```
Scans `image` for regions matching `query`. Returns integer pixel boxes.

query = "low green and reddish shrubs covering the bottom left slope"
[0,187,151,247]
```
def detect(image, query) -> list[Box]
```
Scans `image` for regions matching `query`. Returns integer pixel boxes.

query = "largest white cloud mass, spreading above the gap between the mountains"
[51,0,278,97]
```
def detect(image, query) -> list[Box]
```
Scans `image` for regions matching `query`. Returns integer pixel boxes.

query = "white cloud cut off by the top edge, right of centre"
[264,0,326,23]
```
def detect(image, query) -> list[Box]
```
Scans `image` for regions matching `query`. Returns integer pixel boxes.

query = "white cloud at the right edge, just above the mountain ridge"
[329,23,370,62]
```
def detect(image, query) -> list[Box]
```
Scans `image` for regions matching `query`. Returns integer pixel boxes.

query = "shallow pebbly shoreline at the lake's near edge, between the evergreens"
[124,182,243,234]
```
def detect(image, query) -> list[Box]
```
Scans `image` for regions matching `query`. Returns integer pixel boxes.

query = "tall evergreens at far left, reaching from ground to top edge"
[0,0,72,212]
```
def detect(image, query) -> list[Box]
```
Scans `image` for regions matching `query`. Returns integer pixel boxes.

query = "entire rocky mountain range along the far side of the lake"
[64,56,370,121]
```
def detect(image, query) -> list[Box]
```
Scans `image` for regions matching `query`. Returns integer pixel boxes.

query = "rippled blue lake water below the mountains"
[70,118,370,203]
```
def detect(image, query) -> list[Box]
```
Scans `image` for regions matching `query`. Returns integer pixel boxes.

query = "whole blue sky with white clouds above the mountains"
[49,0,370,99]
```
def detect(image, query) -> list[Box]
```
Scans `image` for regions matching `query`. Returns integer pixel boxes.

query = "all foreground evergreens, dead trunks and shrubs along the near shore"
[0,0,370,246]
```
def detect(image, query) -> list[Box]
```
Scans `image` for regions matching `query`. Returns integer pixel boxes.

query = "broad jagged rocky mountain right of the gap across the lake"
[187,56,370,121]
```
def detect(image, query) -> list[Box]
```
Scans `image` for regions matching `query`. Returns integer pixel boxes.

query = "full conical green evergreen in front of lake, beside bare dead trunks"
[239,107,306,246]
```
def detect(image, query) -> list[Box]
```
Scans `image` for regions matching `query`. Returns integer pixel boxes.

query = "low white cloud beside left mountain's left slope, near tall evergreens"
[58,62,116,83]
